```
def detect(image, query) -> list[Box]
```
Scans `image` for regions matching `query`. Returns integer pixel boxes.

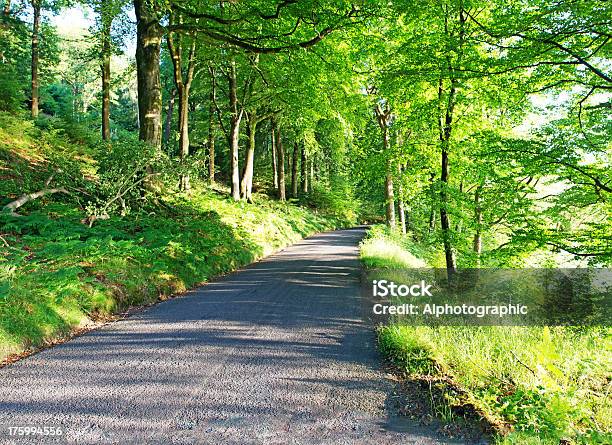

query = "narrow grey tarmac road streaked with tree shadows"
[0,228,462,444]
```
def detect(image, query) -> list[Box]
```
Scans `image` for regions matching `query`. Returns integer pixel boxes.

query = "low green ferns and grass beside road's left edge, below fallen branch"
[0,193,340,357]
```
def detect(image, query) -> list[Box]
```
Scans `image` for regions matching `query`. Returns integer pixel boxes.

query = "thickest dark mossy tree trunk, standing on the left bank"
[134,0,163,148]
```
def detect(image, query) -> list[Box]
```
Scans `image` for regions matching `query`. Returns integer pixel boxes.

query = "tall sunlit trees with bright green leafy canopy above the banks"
[0,0,612,266]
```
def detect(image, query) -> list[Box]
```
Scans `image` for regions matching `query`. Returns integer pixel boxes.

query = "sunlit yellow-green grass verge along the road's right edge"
[362,228,612,445]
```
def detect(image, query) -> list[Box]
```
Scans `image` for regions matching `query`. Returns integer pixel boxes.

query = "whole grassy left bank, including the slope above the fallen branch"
[0,114,342,361]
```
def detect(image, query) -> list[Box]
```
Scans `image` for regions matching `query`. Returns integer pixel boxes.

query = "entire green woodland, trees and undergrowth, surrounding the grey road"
[0,0,612,443]
